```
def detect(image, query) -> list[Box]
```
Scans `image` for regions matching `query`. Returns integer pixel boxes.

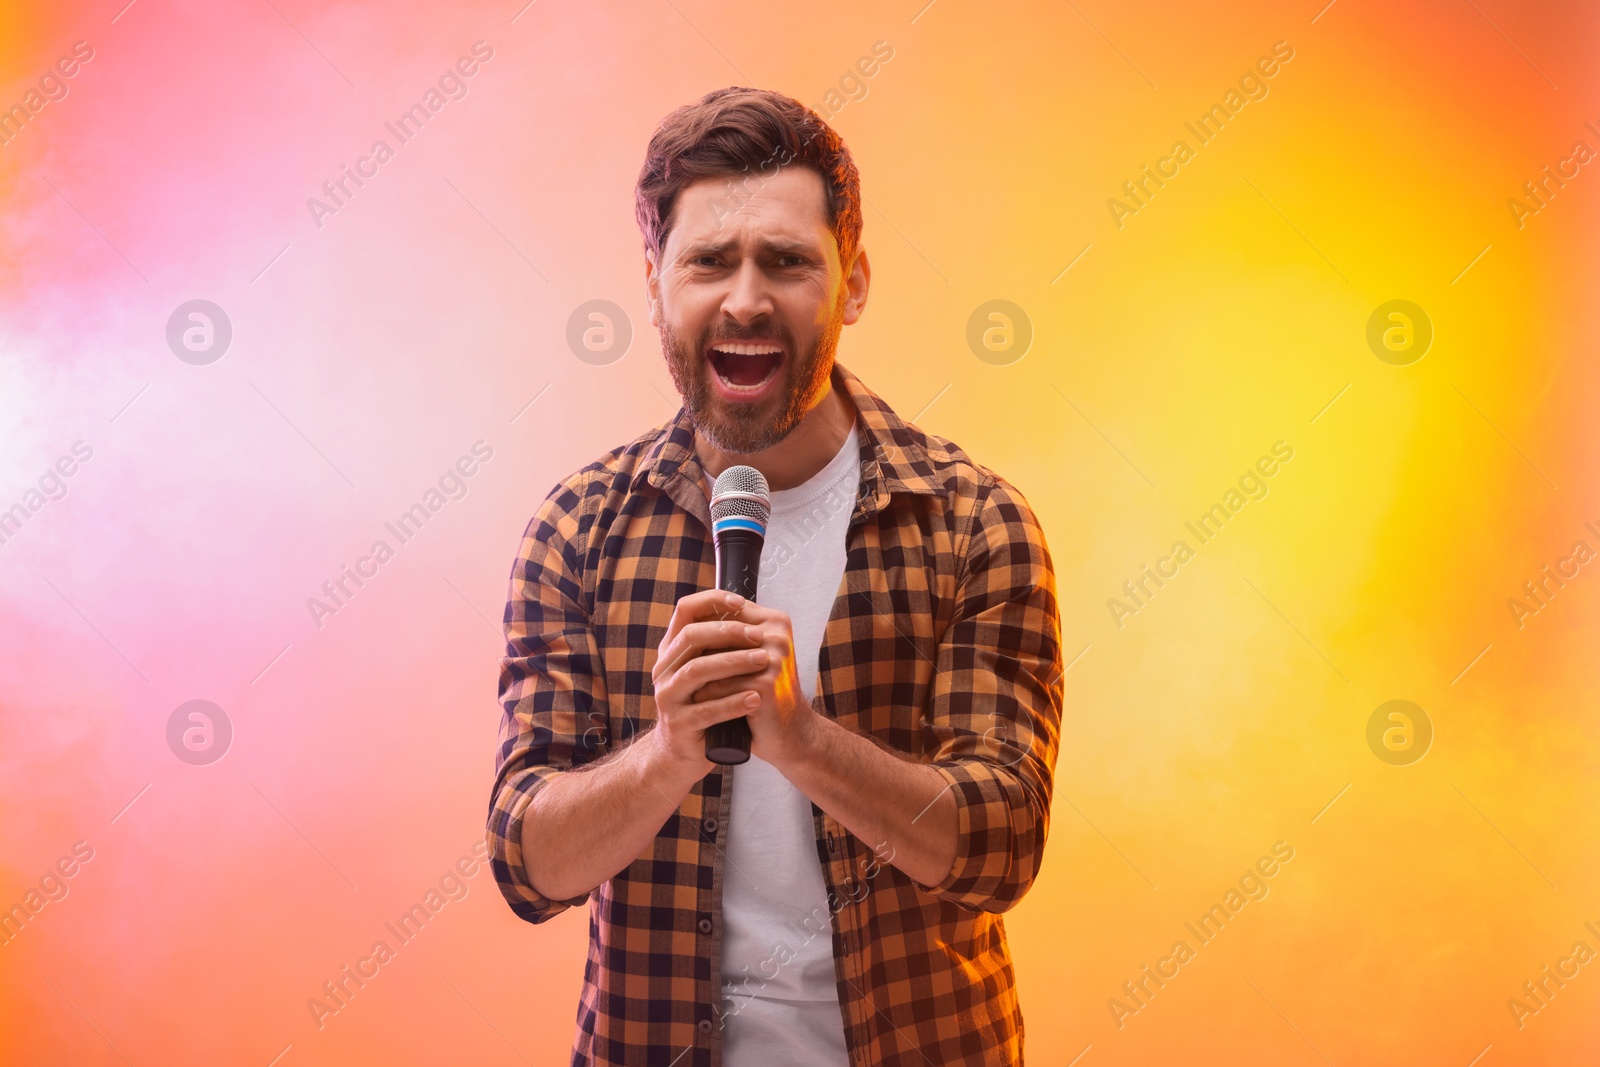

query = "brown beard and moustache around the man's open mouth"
[658,299,845,454]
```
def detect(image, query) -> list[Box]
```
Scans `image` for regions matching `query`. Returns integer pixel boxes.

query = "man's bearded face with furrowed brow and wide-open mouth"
[645,166,866,453]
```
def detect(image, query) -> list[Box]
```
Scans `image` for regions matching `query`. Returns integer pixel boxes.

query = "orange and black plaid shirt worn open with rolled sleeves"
[488,363,1062,1067]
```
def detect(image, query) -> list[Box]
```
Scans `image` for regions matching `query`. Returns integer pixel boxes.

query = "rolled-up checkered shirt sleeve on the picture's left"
[488,480,606,923]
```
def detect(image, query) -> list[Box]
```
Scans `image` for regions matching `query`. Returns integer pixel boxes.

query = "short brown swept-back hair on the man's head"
[634,86,861,270]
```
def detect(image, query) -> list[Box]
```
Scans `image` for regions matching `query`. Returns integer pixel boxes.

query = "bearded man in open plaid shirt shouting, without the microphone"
[488,88,1062,1067]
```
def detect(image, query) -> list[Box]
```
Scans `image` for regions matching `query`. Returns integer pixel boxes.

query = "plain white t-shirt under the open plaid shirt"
[722,426,861,1067]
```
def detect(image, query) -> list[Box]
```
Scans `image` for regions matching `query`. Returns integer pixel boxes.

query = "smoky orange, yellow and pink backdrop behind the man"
[0,0,1600,1067]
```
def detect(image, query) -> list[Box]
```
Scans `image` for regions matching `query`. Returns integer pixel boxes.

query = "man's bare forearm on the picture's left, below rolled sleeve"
[522,731,702,901]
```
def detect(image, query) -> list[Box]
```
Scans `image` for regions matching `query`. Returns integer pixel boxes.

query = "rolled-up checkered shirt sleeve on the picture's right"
[926,478,1062,912]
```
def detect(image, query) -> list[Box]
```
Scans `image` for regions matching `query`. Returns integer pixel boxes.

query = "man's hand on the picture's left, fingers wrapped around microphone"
[651,589,768,781]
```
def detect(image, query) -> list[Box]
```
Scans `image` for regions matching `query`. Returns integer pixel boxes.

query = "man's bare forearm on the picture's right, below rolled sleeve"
[779,715,957,886]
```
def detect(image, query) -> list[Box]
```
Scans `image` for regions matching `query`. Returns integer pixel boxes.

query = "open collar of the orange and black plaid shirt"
[634,362,942,526]
